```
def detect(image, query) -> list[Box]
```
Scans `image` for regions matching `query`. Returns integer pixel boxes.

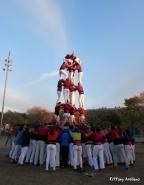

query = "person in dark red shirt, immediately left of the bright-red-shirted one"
[34,125,48,166]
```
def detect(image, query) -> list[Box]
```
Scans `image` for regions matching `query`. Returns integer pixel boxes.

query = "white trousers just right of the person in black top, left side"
[25,139,37,163]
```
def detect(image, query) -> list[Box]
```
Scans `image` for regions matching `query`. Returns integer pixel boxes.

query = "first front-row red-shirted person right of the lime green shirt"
[93,128,105,170]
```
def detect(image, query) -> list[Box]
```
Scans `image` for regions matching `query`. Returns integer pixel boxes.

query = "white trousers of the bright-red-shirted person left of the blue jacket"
[46,144,56,170]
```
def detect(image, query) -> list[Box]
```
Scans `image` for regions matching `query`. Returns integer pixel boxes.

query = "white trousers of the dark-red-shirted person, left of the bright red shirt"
[34,140,45,165]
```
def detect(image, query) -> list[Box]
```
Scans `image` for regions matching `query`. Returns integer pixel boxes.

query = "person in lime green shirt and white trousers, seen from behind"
[70,127,83,170]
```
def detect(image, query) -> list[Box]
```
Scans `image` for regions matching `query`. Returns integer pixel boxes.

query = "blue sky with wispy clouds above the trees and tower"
[0,0,144,112]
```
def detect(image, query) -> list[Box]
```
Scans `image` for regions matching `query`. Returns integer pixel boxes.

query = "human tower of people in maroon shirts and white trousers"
[54,53,85,125]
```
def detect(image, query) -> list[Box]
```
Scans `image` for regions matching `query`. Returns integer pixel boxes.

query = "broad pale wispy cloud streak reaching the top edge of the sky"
[15,0,67,49]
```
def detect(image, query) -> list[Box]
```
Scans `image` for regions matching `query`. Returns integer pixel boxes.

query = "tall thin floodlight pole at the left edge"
[0,51,12,126]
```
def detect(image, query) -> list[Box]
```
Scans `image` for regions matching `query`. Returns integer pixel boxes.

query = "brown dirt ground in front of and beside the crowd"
[0,137,144,185]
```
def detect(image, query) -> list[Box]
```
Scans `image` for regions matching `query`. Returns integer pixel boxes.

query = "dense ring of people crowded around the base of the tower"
[9,122,135,171]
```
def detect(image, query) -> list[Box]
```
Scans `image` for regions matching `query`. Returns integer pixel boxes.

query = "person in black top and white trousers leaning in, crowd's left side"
[18,126,30,165]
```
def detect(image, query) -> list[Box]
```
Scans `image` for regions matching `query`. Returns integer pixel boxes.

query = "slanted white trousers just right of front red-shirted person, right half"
[103,143,113,164]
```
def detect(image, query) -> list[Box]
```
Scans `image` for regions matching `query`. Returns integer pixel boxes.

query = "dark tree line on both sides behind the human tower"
[1,93,144,133]
